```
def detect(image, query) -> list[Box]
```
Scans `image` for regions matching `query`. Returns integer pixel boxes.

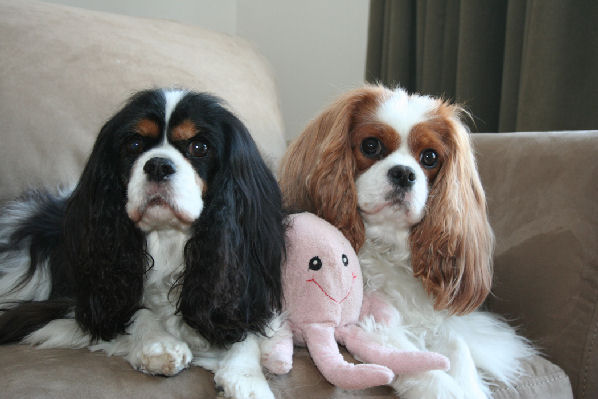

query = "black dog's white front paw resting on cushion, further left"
[137,339,193,376]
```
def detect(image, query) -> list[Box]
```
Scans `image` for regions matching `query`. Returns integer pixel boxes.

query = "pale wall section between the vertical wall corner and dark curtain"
[237,0,369,138]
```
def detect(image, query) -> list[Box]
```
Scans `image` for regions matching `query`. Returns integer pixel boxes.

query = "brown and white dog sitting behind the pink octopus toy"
[279,86,534,399]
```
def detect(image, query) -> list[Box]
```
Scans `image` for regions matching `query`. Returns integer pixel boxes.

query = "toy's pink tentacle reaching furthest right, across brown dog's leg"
[336,325,450,374]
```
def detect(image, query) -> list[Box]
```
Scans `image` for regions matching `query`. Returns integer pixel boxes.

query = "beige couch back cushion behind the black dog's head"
[0,0,285,200]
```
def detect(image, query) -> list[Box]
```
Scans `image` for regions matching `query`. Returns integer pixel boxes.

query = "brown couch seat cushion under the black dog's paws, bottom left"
[0,345,216,399]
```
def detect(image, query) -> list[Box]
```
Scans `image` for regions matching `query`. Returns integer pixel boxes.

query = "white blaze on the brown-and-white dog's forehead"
[376,89,438,147]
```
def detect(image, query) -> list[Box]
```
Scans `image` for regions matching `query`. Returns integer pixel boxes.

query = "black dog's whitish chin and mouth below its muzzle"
[128,197,195,232]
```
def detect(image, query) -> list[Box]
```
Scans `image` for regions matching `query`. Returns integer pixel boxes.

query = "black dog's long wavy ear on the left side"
[63,110,149,340]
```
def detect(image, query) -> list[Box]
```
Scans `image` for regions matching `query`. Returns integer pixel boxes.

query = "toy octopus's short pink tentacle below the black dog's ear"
[260,320,293,374]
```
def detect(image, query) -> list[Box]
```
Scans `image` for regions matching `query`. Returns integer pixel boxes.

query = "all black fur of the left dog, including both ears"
[0,90,284,346]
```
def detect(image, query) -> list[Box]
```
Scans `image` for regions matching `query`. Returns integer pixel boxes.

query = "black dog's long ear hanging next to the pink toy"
[178,111,284,346]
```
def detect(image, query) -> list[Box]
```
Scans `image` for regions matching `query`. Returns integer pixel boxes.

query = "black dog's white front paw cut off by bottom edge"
[214,367,275,399]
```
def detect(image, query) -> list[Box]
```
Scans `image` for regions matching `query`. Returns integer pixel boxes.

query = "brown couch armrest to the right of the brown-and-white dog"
[473,131,598,399]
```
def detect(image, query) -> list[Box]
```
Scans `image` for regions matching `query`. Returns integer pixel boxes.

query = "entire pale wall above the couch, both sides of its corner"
[43,0,369,138]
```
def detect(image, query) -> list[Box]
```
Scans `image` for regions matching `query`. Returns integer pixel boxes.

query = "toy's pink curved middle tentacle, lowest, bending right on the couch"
[303,324,394,389]
